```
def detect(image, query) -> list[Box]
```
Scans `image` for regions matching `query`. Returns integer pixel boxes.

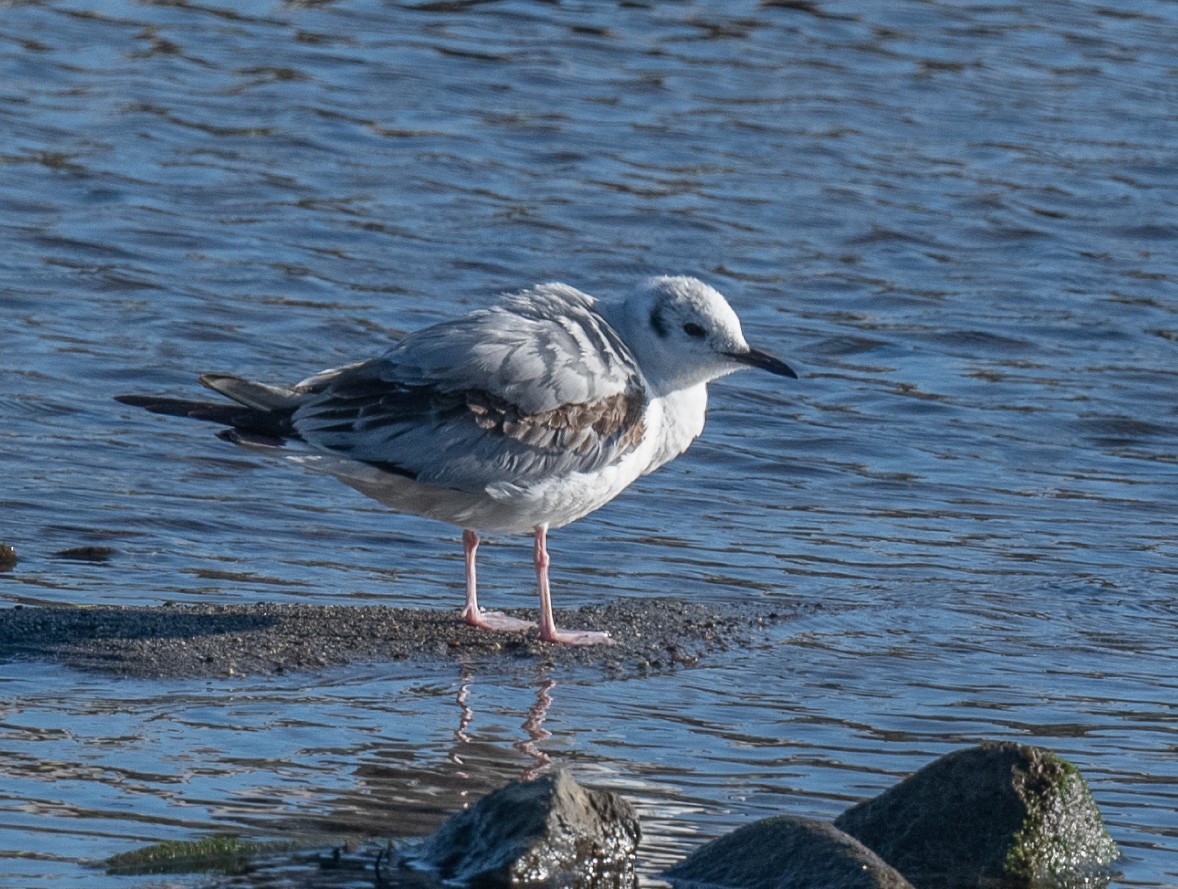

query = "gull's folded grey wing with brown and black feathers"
[293,285,646,490]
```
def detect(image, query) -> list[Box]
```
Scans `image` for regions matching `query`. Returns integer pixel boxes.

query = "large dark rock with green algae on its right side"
[834,743,1118,889]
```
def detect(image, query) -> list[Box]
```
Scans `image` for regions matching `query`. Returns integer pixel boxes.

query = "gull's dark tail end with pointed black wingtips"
[114,373,302,447]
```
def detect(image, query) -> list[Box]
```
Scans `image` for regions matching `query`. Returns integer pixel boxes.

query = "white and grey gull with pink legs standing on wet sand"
[118,276,798,644]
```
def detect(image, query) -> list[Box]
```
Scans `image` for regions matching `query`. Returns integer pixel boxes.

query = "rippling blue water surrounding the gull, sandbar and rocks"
[0,0,1178,888]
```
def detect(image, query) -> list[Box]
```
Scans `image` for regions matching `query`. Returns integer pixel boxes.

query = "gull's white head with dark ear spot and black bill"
[622,276,798,391]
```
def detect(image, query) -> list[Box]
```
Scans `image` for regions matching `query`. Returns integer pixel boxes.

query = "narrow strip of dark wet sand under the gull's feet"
[0,598,794,678]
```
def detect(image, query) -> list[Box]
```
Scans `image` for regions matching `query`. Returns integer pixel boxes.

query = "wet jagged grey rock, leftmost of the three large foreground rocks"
[402,771,640,889]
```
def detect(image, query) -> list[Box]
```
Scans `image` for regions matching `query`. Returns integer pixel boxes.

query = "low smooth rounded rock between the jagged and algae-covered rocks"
[663,815,912,889]
